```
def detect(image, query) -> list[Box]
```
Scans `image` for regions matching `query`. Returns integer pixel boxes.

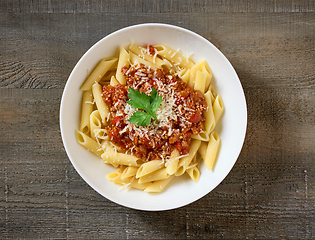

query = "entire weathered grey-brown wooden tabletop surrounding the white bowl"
[0,0,315,239]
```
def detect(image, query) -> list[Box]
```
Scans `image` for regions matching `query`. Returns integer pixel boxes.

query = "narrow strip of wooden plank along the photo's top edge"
[0,0,315,14]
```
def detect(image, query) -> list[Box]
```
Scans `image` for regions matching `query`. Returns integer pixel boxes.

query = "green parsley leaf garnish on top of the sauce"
[127,87,162,127]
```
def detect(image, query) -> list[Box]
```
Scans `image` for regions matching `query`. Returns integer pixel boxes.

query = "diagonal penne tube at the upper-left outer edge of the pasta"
[80,58,117,91]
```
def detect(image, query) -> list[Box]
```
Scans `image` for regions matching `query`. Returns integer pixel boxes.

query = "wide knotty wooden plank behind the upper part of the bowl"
[0,13,315,88]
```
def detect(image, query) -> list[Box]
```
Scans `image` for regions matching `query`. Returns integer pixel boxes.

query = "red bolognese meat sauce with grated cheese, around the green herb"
[103,64,207,161]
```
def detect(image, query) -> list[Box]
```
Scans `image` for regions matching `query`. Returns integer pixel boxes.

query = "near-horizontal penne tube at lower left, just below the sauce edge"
[101,149,142,167]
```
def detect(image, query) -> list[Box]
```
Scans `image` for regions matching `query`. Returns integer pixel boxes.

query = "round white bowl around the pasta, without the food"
[60,23,247,211]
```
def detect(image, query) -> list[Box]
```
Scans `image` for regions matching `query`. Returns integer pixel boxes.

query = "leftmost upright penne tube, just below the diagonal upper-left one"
[79,90,94,134]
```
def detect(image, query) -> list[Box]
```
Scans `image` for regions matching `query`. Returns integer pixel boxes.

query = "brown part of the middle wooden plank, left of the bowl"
[0,89,65,161]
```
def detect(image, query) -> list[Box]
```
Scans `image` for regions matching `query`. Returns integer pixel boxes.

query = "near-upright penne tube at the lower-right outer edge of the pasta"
[203,131,221,170]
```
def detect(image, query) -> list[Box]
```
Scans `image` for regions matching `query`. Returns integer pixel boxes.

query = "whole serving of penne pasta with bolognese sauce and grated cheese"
[75,44,224,193]
